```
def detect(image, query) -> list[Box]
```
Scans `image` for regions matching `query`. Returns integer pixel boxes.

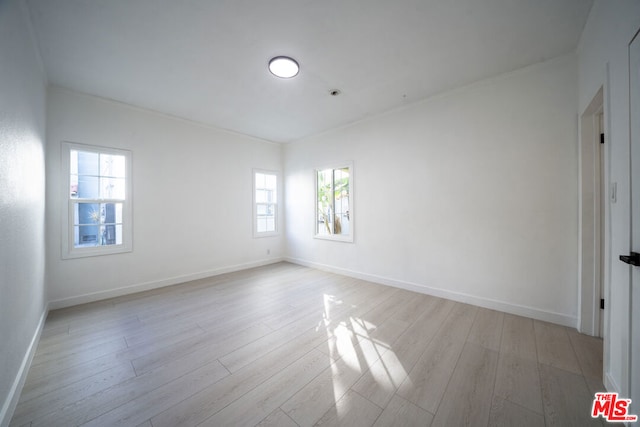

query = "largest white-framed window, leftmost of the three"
[62,142,132,258]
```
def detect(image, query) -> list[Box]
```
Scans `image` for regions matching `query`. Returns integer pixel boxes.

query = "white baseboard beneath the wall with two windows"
[49,257,284,310]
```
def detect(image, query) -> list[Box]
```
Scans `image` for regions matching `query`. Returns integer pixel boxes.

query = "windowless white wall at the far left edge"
[0,0,46,425]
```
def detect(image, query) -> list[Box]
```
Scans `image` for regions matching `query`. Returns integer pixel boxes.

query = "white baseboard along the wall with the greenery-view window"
[284,257,578,328]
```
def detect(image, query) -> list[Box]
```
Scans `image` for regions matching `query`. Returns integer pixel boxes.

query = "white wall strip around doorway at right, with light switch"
[578,0,640,396]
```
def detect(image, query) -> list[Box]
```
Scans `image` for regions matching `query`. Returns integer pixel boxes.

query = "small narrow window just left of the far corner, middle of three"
[253,170,278,237]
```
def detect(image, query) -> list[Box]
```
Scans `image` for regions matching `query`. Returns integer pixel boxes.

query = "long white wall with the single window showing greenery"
[285,55,578,327]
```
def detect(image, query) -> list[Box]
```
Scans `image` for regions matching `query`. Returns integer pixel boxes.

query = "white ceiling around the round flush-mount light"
[27,0,592,142]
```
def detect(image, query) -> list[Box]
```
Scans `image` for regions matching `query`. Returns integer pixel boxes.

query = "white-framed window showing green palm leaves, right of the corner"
[315,165,353,242]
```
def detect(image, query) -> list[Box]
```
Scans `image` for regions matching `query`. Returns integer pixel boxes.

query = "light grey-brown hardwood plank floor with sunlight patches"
[11,263,604,427]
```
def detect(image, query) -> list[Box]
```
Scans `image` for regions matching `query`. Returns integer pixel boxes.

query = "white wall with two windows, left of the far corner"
[47,87,283,307]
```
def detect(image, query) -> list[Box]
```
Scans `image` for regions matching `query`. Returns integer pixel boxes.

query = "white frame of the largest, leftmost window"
[61,141,133,259]
